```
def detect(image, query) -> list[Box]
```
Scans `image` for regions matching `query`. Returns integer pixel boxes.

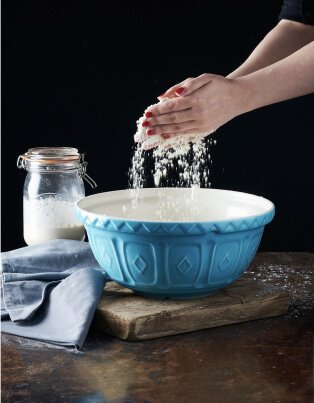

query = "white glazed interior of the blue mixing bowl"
[78,188,274,222]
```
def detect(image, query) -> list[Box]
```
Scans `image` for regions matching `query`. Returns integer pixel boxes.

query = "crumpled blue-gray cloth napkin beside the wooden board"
[1,239,108,348]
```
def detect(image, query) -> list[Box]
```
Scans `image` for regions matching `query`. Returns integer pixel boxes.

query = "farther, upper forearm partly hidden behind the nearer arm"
[228,20,314,78]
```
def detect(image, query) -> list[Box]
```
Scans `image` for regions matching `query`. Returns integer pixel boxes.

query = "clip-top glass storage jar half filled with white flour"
[17,147,97,245]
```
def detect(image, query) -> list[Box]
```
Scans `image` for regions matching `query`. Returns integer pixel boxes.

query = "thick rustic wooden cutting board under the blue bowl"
[94,278,289,340]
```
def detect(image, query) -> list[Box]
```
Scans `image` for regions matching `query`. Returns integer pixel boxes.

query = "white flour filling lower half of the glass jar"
[23,197,85,245]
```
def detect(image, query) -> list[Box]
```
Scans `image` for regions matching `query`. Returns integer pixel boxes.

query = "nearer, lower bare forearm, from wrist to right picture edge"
[234,41,314,114]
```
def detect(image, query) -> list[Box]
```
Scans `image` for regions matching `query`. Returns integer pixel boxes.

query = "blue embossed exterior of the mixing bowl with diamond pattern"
[77,208,274,298]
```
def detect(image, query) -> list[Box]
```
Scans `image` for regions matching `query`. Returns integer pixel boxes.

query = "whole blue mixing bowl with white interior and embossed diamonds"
[77,188,275,298]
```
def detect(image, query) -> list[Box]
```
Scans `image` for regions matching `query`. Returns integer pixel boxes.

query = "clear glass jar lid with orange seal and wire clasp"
[17,147,97,188]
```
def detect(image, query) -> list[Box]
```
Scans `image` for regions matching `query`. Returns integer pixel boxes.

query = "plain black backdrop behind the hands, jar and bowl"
[1,0,314,251]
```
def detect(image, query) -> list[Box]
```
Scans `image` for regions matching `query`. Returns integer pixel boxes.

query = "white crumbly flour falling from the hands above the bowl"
[129,99,216,189]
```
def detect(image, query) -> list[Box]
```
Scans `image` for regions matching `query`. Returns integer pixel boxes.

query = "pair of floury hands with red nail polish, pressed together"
[135,73,241,149]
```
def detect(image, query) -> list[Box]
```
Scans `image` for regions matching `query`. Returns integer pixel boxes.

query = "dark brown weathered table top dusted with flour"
[1,252,314,403]
